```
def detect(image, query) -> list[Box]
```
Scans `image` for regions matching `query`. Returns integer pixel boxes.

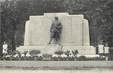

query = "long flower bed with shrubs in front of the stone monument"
[1,50,105,61]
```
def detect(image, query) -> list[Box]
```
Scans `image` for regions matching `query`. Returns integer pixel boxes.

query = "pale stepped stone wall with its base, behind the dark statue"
[17,13,95,54]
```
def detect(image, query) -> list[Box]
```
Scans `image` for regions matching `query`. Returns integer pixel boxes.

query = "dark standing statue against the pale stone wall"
[49,17,62,44]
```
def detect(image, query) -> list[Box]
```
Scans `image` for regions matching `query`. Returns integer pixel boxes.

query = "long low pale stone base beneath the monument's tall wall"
[17,44,96,55]
